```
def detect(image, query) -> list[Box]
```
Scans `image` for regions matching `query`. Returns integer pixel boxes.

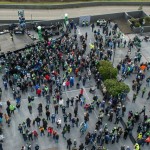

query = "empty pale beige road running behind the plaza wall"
[0,6,150,20]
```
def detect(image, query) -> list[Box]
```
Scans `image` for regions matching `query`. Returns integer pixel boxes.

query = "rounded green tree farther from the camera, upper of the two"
[97,60,118,80]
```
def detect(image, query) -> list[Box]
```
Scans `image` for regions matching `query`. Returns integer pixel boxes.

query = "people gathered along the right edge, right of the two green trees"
[117,46,150,150]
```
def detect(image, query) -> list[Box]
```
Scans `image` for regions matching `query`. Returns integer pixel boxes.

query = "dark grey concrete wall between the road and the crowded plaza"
[0,11,150,33]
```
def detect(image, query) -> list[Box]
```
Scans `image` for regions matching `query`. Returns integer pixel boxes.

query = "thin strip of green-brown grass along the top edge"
[0,0,150,4]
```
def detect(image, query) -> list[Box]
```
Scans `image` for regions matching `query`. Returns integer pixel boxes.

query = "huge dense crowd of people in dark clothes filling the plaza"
[0,17,150,150]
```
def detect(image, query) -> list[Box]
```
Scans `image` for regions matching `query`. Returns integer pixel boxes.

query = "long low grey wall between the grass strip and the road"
[0,2,150,9]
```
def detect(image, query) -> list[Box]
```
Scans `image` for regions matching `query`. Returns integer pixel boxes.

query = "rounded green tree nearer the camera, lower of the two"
[104,79,130,97]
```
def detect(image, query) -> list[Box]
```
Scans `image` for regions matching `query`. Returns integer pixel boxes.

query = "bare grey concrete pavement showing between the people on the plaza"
[0,14,150,150]
